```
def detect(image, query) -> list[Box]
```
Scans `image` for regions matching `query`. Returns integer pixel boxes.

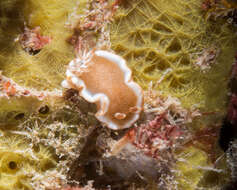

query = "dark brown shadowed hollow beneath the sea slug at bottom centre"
[66,126,158,190]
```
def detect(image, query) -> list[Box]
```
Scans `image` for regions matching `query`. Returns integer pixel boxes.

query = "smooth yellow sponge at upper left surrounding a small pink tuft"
[0,0,88,90]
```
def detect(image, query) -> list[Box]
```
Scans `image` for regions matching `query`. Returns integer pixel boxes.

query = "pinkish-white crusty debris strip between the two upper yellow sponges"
[68,0,118,55]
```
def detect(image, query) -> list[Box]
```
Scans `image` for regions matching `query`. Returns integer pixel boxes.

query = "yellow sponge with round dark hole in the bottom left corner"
[0,135,54,190]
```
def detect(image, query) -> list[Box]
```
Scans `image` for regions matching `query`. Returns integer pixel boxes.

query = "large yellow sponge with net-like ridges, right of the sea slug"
[110,0,237,111]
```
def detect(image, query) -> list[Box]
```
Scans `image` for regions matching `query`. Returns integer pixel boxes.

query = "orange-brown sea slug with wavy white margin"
[62,50,143,130]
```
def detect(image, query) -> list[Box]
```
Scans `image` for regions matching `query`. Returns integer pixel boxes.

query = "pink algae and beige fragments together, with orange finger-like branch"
[111,90,199,156]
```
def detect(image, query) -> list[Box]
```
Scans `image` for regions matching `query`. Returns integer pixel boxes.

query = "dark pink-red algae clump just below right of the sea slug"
[128,114,183,157]
